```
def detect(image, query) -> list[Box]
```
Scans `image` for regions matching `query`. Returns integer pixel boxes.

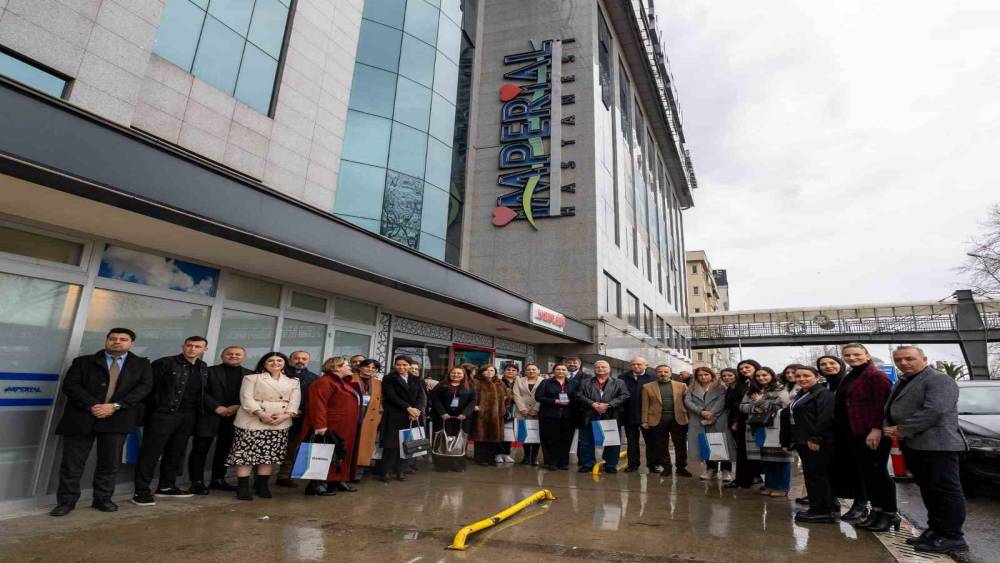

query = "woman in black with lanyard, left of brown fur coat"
[429,366,476,471]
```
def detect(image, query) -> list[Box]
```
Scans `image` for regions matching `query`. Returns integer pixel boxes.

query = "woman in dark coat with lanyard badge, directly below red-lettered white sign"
[535,364,580,470]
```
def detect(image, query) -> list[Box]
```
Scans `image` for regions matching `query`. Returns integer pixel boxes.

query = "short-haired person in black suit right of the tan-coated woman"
[379,356,423,482]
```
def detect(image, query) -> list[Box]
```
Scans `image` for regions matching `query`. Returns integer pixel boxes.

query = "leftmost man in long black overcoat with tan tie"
[49,328,153,516]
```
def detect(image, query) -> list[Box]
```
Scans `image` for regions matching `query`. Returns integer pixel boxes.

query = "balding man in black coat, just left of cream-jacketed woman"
[188,346,252,495]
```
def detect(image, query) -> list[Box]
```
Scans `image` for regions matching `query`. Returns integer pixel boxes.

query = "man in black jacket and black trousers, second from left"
[132,336,208,506]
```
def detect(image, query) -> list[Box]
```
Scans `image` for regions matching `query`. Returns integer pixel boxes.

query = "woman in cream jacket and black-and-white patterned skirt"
[226,352,302,500]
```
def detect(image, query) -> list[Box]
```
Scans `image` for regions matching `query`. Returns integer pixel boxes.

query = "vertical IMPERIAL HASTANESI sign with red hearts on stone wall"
[493,39,576,229]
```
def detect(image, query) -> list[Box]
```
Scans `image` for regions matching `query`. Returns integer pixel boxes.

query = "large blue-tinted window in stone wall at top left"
[153,0,291,113]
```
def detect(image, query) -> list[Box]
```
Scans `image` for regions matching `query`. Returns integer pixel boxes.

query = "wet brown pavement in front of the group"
[0,464,894,563]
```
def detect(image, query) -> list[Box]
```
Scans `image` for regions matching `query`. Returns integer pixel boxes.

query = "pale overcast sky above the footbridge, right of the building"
[656,0,1000,366]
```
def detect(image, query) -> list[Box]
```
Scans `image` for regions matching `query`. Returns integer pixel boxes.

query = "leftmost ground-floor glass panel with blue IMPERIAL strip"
[0,274,80,501]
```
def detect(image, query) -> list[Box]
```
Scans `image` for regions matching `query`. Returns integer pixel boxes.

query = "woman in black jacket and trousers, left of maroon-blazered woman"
[788,365,840,524]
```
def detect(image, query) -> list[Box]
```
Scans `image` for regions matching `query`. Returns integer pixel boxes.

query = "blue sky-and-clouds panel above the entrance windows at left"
[97,244,219,296]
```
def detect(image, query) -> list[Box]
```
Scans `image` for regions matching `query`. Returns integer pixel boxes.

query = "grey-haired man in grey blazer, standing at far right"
[883,346,969,553]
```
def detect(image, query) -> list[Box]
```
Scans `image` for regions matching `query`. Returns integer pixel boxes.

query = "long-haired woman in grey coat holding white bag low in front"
[684,367,736,481]
